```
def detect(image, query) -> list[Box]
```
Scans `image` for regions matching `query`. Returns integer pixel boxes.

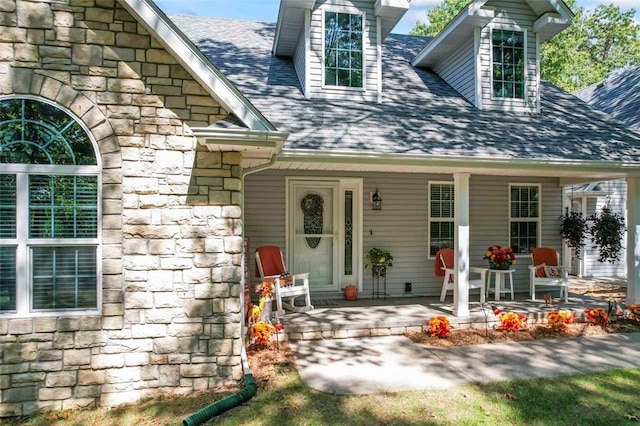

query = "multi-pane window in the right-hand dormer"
[491,28,525,99]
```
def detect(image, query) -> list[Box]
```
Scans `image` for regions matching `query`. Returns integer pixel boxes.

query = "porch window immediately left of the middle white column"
[429,182,455,257]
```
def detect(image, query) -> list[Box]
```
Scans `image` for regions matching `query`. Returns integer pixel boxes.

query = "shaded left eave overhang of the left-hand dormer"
[272,0,316,57]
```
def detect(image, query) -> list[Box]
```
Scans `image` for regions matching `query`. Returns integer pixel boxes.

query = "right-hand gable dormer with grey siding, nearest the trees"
[412,0,573,112]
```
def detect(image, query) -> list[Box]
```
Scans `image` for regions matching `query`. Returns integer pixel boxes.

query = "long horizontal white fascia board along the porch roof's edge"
[278,149,640,176]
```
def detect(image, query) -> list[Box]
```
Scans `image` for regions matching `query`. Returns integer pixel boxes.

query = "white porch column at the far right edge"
[627,178,640,305]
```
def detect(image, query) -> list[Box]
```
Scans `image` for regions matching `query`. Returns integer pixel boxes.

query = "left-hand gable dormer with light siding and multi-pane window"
[273,0,409,102]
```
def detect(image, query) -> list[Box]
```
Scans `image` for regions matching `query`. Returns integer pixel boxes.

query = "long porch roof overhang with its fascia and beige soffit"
[243,149,640,181]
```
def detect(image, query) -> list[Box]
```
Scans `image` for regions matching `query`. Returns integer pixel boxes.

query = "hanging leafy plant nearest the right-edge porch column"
[589,206,627,263]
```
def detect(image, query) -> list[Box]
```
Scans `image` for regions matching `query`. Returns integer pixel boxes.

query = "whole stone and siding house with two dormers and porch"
[0,0,640,416]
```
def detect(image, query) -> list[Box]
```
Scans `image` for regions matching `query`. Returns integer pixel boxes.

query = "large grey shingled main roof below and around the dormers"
[170,15,640,167]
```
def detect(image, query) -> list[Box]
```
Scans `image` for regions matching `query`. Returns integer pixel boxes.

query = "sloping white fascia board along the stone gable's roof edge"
[118,0,276,130]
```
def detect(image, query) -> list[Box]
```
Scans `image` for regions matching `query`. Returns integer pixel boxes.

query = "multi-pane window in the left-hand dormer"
[324,12,363,88]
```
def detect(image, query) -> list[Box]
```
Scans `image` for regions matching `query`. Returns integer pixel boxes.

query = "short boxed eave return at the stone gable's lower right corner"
[191,127,289,163]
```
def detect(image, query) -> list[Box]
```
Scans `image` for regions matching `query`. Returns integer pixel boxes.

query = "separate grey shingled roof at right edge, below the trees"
[575,67,640,130]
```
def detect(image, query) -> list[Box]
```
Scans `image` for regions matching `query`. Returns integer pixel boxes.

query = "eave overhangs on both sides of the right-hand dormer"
[411,0,574,68]
